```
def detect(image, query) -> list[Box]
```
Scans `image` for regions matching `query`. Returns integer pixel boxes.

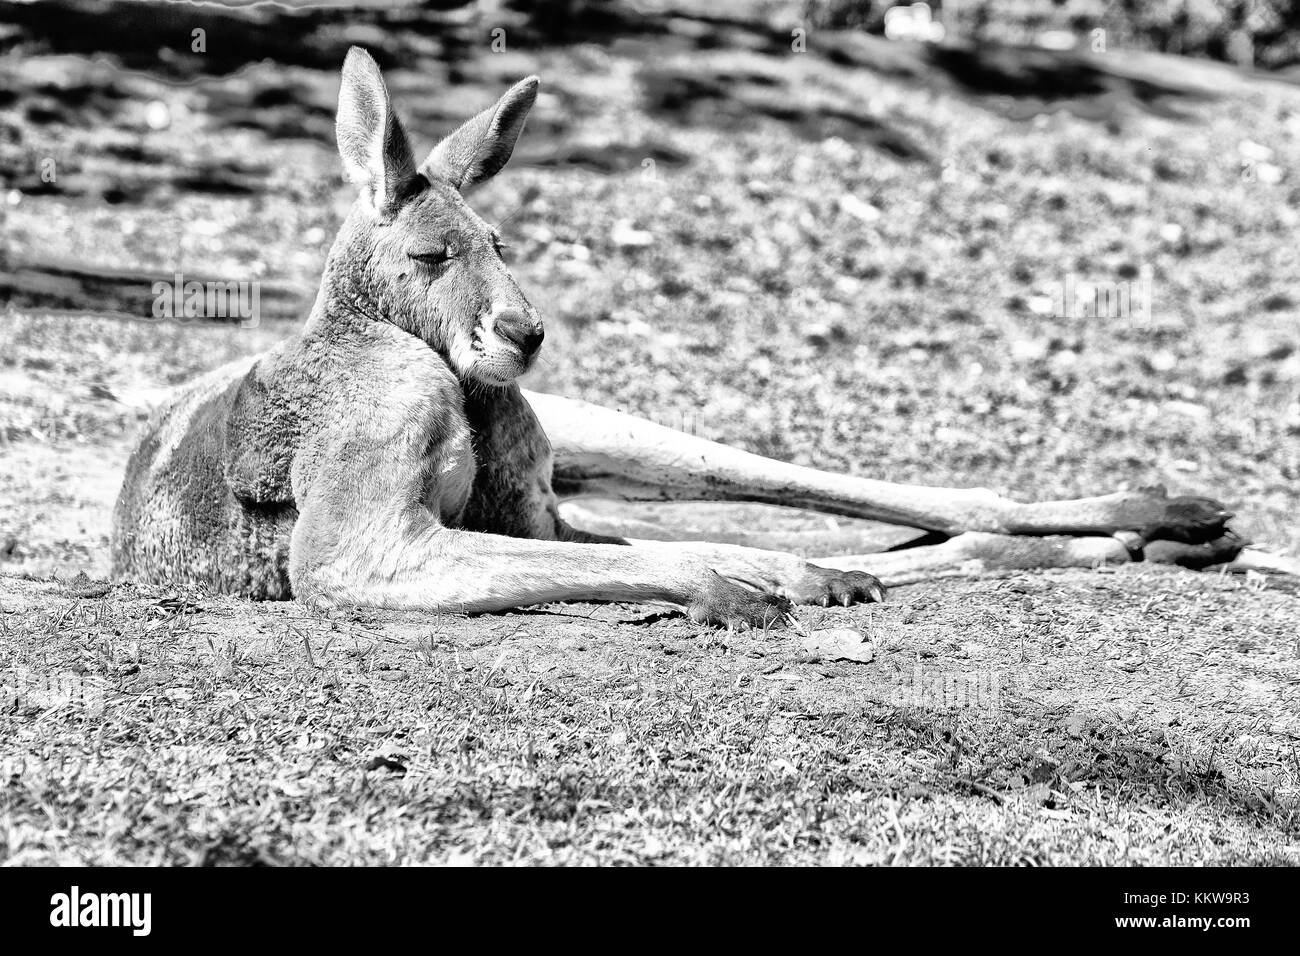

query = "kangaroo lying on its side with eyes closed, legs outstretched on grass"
[112,47,1268,627]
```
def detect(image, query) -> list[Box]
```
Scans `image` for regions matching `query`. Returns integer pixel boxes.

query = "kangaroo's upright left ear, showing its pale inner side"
[334,47,416,212]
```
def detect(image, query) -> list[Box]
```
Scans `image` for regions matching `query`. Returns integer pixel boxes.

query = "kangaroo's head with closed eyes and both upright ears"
[324,47,542,385]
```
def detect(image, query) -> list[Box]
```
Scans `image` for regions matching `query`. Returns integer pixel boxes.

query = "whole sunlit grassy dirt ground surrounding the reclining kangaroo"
[0,1,1300,864]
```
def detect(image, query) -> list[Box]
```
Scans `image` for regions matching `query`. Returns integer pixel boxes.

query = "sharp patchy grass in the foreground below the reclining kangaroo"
[0,568,1300,864]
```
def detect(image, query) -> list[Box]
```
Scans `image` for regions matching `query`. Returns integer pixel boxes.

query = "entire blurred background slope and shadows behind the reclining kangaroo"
[0,0,1300,575]
